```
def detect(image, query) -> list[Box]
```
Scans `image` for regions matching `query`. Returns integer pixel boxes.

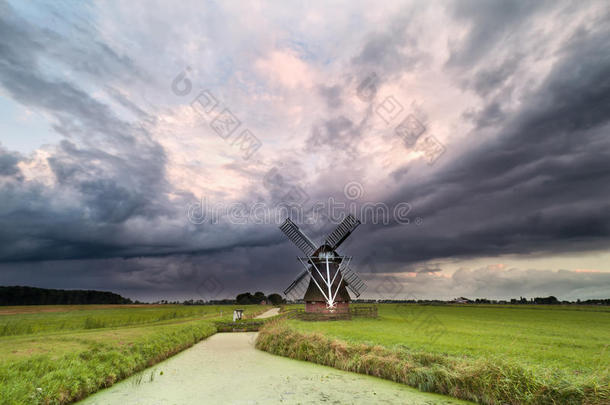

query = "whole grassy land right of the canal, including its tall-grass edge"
[257,305,610,404]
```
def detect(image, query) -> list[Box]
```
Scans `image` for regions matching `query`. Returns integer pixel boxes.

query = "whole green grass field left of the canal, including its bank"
[0,305,268,405]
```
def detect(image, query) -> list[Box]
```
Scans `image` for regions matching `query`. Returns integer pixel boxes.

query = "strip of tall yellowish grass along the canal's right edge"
[256,321,610,405]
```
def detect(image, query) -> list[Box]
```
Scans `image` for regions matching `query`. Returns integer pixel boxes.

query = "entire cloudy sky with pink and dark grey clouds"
[0,0,610,300]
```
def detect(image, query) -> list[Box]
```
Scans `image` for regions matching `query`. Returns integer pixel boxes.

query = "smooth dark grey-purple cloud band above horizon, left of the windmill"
[0,240,302,300]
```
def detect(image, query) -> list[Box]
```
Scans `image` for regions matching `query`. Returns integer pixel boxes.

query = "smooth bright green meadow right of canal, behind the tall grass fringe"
[290,304,610,376]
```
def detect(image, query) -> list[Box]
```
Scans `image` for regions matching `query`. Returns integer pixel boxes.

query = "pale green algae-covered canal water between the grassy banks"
[80,332,466,405]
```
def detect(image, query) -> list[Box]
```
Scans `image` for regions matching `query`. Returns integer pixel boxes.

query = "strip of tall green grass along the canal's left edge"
[0,321,216,405]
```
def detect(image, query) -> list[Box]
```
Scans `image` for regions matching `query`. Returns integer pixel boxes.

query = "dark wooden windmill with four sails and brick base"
[280,214,366,312]
